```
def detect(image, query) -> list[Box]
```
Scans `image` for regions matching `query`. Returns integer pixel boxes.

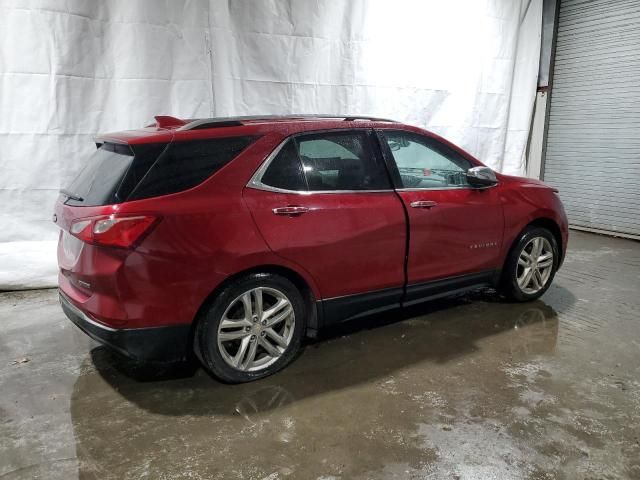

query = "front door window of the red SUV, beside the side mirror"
[381,131,472,188]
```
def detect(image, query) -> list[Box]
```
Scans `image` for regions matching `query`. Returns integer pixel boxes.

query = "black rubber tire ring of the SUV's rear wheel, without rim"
[195,273,306,383]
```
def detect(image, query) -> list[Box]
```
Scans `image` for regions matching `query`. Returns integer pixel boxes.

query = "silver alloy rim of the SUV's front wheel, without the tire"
[516,237,553,295]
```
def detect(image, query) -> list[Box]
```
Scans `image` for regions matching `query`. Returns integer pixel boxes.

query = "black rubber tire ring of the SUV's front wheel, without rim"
[503,227,560,302]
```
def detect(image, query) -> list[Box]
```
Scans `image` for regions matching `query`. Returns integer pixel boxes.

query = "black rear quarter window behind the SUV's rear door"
[129,137,254,200]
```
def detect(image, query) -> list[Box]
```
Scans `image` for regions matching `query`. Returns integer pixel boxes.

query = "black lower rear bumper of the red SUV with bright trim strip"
[59,291,191,362]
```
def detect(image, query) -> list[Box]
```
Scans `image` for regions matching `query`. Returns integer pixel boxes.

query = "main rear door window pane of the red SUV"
[296,131,391,191]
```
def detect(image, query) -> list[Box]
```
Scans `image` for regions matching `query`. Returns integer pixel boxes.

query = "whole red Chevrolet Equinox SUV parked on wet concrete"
[54,116,568,382]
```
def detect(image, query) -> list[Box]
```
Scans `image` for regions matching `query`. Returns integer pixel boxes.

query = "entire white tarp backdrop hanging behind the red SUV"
[0,0,542,290]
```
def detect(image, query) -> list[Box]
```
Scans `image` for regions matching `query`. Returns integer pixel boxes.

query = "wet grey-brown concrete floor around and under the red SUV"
[0,232,640,480]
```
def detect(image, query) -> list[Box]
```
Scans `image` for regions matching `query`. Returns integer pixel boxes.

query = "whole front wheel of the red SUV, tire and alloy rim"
[500,226,560,302]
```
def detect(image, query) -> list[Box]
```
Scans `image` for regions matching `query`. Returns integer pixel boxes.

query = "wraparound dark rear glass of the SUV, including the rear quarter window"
[62,137,255,206]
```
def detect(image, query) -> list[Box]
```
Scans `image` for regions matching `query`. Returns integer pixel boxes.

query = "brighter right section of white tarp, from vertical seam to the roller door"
[210,0,542,174]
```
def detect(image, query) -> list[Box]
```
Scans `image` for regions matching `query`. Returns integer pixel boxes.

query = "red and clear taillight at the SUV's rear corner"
[69,214,159,248]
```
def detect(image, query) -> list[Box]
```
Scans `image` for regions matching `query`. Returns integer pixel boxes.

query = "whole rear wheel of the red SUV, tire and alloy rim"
[194,273,306,383]
